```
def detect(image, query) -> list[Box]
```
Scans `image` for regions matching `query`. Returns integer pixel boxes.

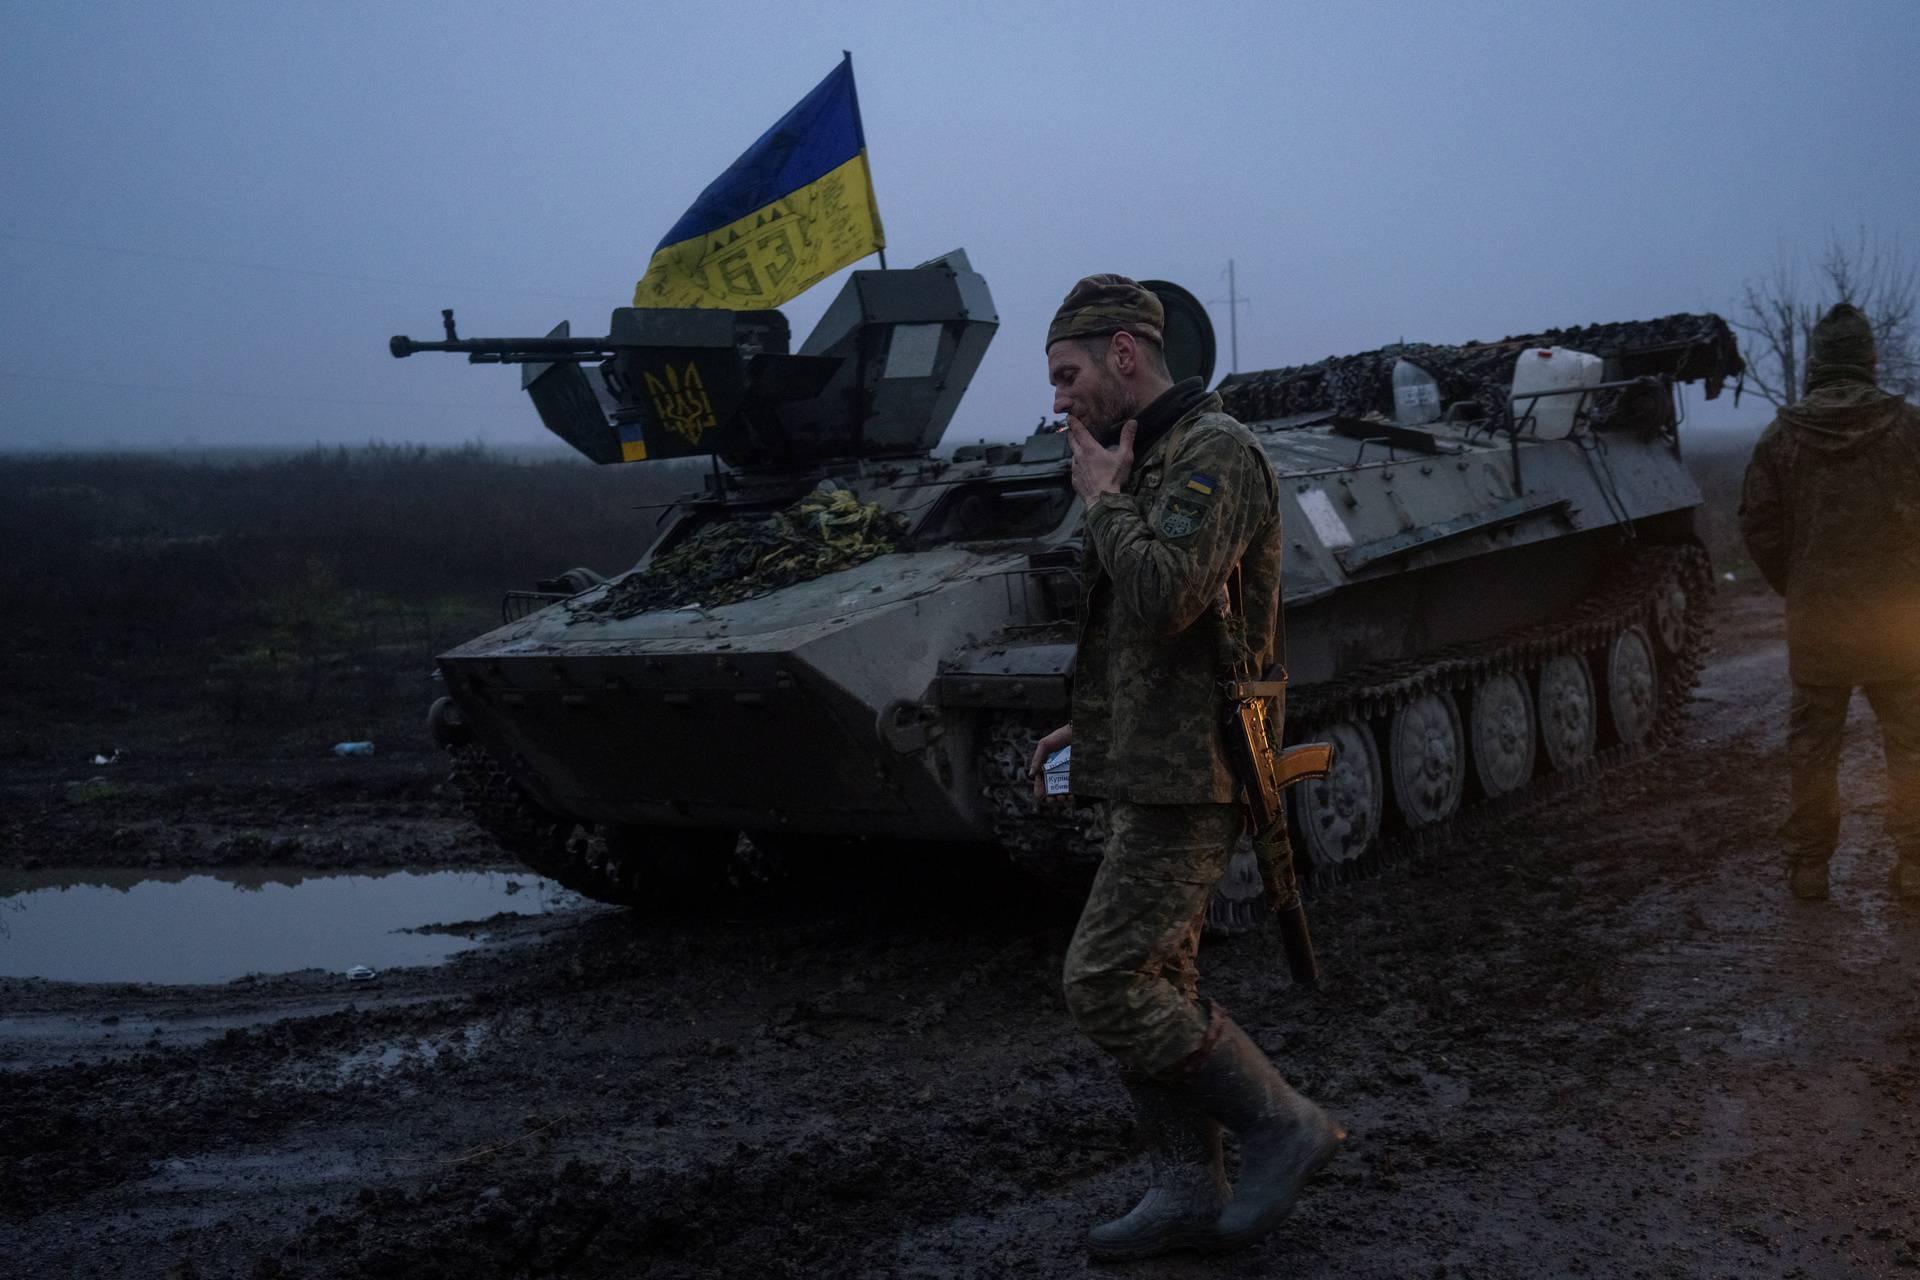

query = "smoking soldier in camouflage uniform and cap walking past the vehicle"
[1031,276,1344,1257]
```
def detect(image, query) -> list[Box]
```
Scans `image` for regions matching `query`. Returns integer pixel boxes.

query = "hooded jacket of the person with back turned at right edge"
[1743,374,1920,687]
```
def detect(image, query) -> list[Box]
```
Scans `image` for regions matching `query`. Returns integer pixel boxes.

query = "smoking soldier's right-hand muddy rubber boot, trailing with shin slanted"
[1185,1009,1346,1253]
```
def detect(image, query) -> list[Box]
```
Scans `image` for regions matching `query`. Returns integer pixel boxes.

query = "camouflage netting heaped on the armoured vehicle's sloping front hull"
[568,489,906,618]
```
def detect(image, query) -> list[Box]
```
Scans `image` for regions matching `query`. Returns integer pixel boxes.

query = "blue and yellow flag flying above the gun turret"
[634,58,887,311]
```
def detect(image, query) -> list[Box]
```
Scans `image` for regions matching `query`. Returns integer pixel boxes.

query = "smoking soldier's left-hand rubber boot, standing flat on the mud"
[1087,1077,1227,1259]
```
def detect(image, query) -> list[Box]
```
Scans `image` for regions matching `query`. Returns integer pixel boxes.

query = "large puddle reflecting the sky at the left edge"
[0,869,582,983]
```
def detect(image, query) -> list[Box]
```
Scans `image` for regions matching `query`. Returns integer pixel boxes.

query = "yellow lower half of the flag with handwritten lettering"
[634,152,887,311]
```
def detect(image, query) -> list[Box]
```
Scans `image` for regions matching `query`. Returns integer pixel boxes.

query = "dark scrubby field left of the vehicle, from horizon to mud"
[0,445,701,756]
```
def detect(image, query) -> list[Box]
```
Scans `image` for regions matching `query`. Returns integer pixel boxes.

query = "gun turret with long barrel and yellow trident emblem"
[388,249,998,466]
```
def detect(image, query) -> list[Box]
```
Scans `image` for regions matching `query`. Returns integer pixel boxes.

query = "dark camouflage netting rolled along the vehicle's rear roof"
[1219,315,1745,428]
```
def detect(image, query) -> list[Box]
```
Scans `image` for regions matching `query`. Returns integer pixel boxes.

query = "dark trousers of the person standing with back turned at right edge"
[1786,677,1920,865]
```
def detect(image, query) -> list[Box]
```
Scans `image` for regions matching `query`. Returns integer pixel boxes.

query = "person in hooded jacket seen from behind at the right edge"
[1740,303,1920,900]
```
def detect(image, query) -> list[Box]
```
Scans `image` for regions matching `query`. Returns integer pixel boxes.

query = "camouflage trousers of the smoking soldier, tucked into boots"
[1062,802,1242,1075]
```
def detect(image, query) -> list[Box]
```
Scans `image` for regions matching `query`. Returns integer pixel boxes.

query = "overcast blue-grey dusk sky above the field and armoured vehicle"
[0,0,1920,449]
